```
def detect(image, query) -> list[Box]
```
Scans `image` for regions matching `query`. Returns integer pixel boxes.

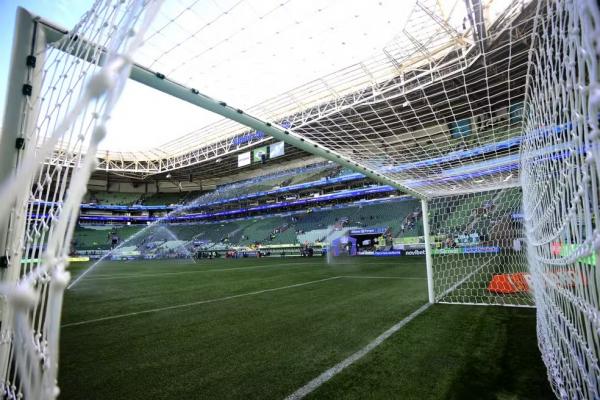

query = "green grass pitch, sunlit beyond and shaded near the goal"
[59,257,554,399]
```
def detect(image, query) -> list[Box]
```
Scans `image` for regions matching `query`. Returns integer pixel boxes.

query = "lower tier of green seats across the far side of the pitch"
[75,199,420,250]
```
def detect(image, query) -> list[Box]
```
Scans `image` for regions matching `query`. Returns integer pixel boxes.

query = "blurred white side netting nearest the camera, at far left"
[0,0,159,399]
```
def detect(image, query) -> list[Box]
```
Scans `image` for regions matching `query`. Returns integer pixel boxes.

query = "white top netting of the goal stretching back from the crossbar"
[88,0,535,169]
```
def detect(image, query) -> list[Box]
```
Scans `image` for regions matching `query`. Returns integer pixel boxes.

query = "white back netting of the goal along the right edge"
[521,0,600,399]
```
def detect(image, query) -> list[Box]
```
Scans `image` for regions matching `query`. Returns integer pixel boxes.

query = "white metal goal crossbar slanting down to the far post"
[40,16,425,198]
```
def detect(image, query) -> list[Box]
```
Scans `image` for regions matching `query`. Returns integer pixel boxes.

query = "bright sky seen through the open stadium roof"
[0,0,414,151]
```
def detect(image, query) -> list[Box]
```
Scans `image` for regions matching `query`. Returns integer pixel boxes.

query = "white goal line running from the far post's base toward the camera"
[285,303,431,400]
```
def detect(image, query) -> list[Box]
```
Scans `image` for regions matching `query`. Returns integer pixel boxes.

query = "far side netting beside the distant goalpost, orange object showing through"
[429,188,533,306]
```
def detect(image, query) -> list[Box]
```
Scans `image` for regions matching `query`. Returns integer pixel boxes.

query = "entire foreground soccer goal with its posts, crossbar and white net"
[0,0,600,399]
